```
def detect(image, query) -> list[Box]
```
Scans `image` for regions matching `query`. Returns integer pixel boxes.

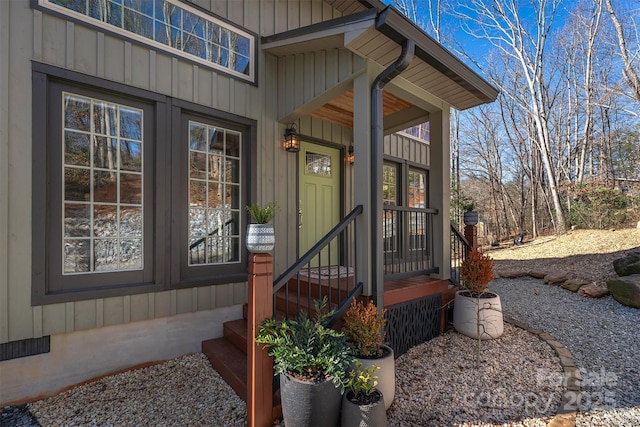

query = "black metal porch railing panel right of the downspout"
[382,205,438,279]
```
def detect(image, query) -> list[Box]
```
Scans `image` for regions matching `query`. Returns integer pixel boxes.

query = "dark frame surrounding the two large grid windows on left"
[31,61,252,305]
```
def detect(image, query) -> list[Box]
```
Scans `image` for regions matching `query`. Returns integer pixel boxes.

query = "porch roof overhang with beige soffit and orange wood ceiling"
[262,6,498,124]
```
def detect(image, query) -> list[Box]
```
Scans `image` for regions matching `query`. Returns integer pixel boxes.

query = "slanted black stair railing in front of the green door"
[273,205,363,326]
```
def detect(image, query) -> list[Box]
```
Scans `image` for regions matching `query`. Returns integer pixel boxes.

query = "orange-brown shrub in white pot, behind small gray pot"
[342,299,396,409]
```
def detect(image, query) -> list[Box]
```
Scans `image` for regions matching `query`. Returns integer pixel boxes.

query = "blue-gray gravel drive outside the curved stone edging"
[489,278,640,426]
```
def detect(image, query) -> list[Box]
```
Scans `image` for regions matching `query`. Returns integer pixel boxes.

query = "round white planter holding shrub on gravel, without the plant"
[453,290,504,340]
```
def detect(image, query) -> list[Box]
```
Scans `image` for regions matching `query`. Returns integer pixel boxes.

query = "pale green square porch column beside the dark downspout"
[353,64,374,295]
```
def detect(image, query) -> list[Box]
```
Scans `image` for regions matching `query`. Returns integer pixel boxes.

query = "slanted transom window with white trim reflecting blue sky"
[39,0,255,82]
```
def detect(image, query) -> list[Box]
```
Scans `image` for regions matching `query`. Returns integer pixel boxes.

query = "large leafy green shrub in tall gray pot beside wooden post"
[256,298,353,427]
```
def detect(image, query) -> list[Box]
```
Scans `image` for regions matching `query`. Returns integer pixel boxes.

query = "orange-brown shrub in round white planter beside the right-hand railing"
[453,249,504,362]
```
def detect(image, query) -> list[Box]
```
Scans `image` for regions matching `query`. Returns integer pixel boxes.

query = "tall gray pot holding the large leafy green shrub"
[280,374,342,427]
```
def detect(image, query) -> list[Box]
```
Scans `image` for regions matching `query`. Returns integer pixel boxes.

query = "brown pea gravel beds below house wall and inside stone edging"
[3,325,563,427]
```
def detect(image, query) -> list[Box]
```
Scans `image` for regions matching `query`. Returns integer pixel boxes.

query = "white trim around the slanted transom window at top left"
[38,0,256,83]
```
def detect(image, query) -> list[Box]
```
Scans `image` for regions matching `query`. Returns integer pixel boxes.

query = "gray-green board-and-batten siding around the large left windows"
[0,0,350,343]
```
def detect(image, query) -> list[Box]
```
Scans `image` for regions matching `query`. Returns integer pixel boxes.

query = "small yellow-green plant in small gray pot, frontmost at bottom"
[341,361,387,427]
